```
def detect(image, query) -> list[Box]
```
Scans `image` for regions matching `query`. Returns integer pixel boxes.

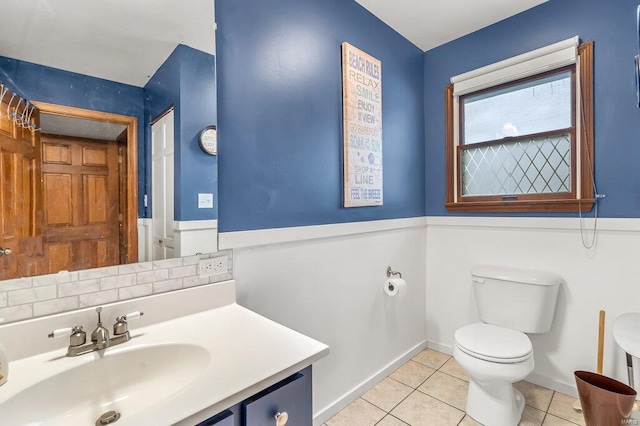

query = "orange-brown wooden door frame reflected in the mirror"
[31,101,138,263]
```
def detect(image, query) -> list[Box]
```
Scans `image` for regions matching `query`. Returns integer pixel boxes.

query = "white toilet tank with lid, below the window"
[471,265,562,333]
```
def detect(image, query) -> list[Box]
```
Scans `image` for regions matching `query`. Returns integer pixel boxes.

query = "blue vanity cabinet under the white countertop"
[196,366,313,426]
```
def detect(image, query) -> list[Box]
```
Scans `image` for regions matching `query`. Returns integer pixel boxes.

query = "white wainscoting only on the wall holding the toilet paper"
[220,218,427,425]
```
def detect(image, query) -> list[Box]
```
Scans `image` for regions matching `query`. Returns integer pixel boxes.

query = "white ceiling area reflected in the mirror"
[0,0,215,87]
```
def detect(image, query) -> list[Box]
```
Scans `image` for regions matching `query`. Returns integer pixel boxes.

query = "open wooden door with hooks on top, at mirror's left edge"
[0,96,48,279]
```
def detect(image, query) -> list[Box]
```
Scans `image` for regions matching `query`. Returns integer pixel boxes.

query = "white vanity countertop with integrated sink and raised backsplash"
[0,281,329,426]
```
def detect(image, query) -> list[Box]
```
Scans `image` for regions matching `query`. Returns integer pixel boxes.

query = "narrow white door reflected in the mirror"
[151,110,175,260]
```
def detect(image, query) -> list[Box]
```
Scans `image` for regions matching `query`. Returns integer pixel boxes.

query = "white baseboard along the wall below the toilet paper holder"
[313,341,427,426]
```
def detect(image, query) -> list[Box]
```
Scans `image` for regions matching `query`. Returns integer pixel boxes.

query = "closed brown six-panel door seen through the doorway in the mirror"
[42,134,120,272]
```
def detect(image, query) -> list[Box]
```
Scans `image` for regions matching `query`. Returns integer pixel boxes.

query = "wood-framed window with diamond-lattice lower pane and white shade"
[445,37,594,212]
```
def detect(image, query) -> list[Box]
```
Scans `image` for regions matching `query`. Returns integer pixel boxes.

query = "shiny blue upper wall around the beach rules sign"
[216,0,425,231]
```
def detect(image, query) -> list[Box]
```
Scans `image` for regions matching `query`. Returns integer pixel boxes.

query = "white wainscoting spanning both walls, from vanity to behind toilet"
[220,216,640,424]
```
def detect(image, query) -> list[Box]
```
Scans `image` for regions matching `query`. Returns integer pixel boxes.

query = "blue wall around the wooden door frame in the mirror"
[0,56,145,217]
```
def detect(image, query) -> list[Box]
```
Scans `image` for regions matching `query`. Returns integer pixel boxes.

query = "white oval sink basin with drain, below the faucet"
[0,341,211,426]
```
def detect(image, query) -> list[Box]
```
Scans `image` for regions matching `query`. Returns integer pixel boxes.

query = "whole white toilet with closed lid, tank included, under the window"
[453,265,562,426]
